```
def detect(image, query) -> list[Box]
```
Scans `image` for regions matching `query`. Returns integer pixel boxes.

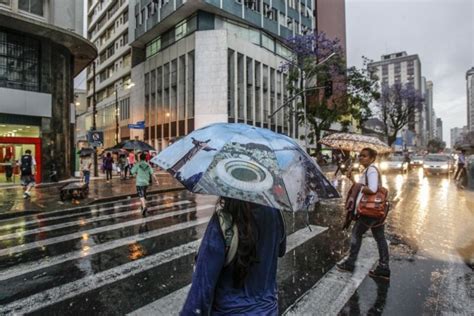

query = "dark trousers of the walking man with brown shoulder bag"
[346,216,389,269]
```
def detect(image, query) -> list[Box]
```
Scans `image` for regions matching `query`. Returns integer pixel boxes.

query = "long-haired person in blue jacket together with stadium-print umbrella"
[152,123,339,315]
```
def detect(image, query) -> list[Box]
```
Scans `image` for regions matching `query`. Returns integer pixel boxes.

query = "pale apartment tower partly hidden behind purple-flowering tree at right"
[368,52,426,146]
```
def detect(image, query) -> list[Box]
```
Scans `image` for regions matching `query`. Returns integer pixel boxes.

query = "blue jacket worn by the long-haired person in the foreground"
[181,206,286,315]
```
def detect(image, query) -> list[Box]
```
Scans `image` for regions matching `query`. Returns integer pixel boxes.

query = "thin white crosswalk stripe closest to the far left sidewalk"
[0,193,186,230]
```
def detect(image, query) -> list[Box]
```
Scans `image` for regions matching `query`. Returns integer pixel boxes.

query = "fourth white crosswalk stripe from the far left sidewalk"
[0,212,214,281]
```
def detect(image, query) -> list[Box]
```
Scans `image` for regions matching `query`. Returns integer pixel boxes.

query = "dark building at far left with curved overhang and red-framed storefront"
[0,0,97,182]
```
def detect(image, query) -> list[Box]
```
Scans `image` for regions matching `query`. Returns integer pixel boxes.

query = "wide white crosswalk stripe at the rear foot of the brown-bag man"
[283,237,378,316]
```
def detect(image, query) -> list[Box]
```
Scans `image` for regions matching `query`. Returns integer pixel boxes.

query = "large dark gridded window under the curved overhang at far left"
[0,31,40,91]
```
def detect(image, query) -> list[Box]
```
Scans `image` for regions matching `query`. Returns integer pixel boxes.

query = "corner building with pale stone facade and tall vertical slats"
[130,0,315,149]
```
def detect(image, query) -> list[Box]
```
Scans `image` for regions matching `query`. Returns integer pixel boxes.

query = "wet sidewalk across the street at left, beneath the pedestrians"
[0,171,184,219]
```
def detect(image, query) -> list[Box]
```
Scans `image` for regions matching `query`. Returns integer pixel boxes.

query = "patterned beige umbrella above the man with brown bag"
[319,133,392,154]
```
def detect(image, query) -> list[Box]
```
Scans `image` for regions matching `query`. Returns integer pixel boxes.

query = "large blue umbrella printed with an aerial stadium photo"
[151,123,340,211]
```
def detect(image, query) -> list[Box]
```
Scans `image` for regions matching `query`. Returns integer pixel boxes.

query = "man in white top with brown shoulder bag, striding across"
[336,148,390,280]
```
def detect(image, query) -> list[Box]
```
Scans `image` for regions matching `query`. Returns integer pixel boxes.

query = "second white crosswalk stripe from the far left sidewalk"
[0,200,191,240]
